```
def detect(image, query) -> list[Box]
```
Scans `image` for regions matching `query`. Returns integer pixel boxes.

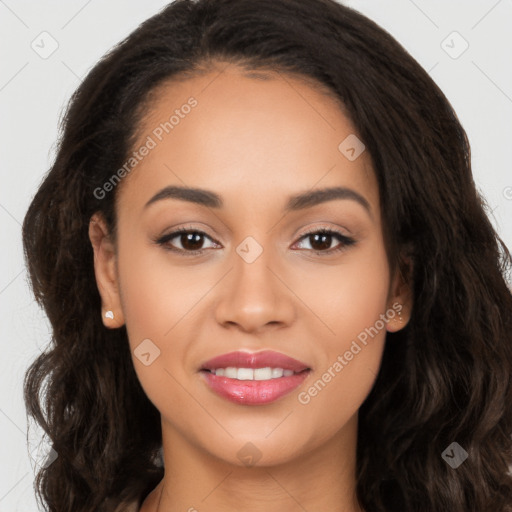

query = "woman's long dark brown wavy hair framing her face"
[23,0,512,512]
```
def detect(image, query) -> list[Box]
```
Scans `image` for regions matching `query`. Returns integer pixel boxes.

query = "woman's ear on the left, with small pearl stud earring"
[89,212,124,329]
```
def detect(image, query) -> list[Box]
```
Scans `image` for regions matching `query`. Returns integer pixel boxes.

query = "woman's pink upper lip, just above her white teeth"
[201,350,310,372]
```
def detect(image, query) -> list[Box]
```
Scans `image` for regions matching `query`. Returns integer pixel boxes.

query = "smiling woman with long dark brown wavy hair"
[23,0,512,512]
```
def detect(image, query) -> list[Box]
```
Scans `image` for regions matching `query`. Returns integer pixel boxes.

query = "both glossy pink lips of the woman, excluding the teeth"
[200,350,311,405]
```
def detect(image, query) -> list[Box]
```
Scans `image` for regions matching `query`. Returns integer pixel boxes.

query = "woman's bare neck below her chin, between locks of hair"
[145,414,362,512]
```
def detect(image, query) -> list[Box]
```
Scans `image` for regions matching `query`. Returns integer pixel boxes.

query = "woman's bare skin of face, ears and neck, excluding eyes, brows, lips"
[90,66,410,512]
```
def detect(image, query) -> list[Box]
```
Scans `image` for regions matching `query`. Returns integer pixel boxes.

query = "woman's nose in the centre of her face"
[215,238,295,332]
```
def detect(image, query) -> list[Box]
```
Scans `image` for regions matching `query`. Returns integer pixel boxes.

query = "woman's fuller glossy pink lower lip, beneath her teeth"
[201,370,310,405]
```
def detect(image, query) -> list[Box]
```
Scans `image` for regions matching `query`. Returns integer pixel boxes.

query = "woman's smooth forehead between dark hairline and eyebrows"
[119,67,378,216]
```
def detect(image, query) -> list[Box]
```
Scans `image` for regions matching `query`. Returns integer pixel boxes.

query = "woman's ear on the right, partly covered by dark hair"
[386,256,413,332]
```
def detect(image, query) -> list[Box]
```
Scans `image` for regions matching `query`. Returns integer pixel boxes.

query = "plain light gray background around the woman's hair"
[0,0,512,512]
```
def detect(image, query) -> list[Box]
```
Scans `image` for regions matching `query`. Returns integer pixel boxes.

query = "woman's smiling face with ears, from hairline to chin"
[90,64,407,465]
